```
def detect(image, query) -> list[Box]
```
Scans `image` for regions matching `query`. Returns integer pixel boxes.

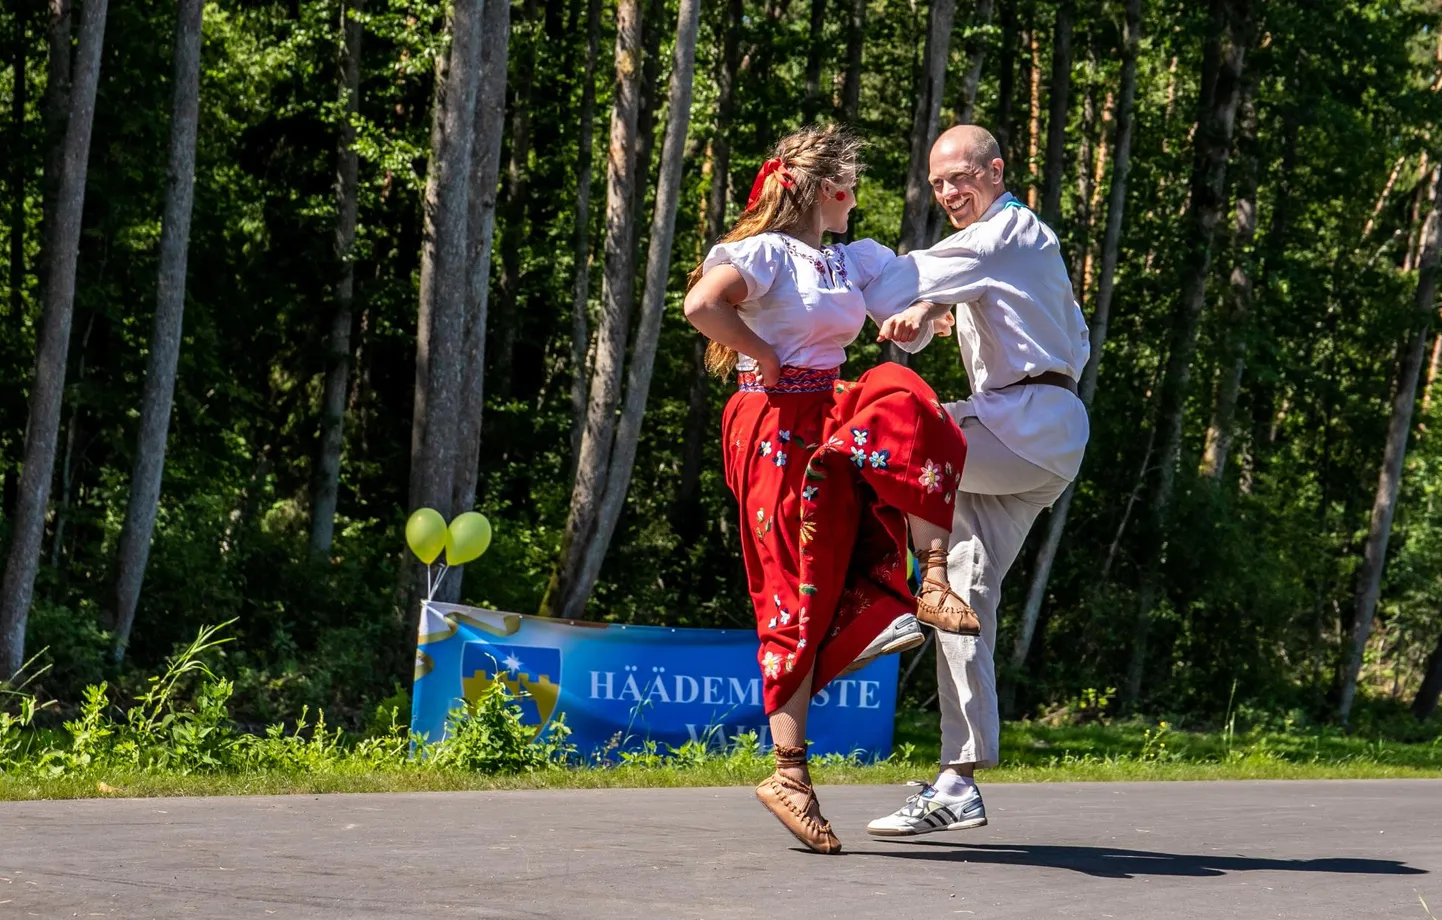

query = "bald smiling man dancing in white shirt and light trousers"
[865,125,1090,836]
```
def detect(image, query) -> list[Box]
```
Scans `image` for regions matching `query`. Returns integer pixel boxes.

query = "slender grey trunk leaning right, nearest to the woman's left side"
[567,0,701,605]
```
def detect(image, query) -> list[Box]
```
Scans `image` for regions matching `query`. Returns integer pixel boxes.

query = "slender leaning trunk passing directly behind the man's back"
[1011,0,1142,706]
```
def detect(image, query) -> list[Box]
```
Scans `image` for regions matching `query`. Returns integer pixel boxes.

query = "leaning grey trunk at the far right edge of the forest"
[1337,160,1442,725]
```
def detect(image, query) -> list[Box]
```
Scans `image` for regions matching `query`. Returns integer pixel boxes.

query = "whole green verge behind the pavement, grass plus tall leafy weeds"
[0,629,1442,800]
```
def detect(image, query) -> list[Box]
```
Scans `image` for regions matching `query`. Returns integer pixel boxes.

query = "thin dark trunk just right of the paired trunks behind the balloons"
[489,0,538,399]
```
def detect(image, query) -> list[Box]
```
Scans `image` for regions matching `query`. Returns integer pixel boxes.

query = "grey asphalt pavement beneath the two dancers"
[0,780,1442,920]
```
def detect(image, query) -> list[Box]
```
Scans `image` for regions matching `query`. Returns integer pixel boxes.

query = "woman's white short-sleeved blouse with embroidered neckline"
[702,234,929,371]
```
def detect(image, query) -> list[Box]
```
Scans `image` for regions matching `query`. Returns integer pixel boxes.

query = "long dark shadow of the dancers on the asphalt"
[851,841,1428,878]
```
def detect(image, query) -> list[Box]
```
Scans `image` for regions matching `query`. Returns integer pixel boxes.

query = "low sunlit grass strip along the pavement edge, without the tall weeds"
[0,712,1442,802]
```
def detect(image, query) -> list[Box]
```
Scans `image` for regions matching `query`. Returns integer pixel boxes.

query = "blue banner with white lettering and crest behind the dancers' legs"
[411,603,898,757]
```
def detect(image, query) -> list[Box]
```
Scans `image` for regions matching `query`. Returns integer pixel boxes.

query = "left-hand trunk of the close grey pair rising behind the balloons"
[410,0,482,519]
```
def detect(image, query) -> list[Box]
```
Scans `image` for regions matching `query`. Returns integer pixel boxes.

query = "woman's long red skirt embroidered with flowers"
[721,363,966,714]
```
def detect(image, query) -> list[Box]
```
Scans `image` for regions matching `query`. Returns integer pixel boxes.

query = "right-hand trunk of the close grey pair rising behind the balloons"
[447,0,510,519]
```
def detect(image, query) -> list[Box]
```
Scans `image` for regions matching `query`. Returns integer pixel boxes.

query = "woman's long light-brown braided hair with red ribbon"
[686,124,862,376]
